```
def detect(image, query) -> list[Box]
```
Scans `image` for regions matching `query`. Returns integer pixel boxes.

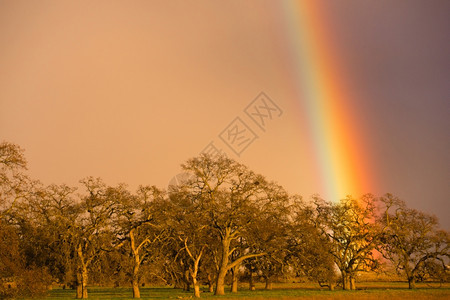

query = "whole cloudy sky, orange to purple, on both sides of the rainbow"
[0,0,450,228]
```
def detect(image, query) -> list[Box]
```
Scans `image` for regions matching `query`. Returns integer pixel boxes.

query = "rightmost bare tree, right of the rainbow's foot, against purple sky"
[379,194,450,289]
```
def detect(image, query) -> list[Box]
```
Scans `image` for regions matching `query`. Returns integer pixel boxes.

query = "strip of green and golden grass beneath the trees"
[37,282,450,300]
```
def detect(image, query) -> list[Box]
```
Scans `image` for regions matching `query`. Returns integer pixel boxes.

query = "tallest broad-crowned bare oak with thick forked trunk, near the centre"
[178,155,286,295]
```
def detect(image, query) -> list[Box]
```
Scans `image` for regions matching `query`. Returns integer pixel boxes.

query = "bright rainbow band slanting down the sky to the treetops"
[280,0,373,201]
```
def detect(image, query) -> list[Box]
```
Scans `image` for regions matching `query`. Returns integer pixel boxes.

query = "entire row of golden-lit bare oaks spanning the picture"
[0,142,449,298]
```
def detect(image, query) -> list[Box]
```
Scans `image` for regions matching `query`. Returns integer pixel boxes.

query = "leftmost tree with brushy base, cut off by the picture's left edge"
[0,142,56,297]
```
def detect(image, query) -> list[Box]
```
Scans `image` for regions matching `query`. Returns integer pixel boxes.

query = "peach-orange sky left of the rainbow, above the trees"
[0,1,314,191]
